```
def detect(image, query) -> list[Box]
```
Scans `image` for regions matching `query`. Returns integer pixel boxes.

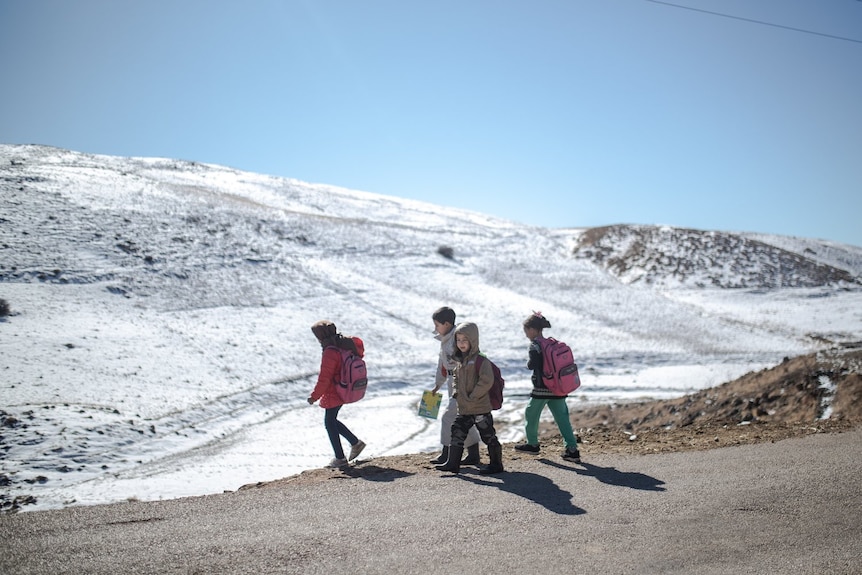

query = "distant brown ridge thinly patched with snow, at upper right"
[573,225,862,289]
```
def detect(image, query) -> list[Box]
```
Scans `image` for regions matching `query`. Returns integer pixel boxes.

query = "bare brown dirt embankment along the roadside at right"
[568,344,862,454]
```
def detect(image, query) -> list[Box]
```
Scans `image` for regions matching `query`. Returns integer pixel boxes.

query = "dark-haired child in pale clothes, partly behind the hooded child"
[431,307,481,465]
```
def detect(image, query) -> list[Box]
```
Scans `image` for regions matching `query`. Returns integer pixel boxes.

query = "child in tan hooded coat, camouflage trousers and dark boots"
[437,322,503,475]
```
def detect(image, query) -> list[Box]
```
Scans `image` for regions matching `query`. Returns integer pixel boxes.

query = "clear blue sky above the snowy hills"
[5,0,862,246]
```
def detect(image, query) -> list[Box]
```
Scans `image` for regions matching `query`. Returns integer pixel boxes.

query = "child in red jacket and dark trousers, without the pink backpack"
[308,320,365,467]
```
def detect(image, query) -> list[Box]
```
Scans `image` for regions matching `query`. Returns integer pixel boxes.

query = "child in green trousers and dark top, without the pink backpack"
[515,312,581,463]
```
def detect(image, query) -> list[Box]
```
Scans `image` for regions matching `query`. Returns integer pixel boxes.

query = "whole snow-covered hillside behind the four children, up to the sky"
[5,145,862,508]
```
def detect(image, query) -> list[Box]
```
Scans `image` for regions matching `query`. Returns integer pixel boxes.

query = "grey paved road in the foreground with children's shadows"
[0,429,862,575]
